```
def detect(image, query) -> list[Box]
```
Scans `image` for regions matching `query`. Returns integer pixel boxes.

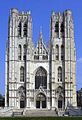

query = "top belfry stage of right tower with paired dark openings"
[51,12,64,39]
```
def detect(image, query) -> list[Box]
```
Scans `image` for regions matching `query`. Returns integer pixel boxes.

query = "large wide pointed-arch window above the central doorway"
[35,67,47,89]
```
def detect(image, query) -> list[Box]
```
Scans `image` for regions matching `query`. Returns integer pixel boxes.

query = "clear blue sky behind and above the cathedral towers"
[0,0,82,94]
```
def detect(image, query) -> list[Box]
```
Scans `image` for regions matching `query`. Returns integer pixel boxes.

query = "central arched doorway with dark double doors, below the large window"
[36,93,46,109]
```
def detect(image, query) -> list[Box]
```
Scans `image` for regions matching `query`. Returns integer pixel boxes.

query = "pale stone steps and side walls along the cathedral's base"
[0,108,82,117]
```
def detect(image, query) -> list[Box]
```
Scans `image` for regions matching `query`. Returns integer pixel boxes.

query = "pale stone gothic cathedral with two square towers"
[5,9,77,110]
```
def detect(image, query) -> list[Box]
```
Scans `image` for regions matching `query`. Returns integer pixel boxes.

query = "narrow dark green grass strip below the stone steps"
[0,117,82,120]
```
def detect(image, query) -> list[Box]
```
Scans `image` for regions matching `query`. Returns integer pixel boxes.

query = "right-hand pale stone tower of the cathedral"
[50,10,77,108]
